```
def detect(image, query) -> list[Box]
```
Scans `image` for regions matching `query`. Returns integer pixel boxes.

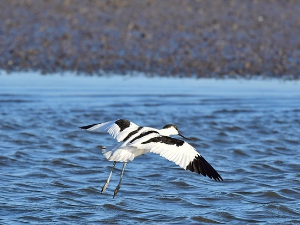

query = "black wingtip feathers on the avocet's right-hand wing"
[186,155,223,181]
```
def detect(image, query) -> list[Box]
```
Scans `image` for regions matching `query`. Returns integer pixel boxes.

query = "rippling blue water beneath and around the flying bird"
[0,74,300,224]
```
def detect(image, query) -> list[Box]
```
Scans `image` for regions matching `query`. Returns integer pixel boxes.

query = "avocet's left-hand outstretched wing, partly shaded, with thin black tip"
[80,119,142,142]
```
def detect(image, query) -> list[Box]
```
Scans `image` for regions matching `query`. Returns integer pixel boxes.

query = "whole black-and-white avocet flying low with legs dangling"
[80,119,223,196]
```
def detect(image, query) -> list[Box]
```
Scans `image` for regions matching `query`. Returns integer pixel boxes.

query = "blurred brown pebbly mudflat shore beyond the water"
[0,0,300,79]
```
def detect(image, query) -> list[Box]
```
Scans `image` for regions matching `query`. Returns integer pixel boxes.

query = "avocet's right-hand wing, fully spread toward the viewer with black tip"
[130,136,223,181]
